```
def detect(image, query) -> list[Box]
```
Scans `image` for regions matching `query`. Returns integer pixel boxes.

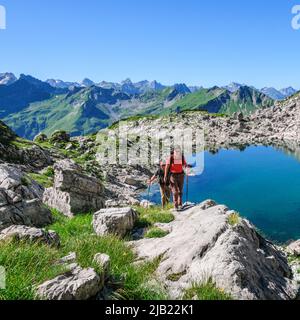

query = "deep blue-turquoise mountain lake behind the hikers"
[146,147,300,242]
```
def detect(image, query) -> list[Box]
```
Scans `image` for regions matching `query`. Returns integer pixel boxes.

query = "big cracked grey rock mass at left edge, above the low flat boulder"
[0,164,52,230]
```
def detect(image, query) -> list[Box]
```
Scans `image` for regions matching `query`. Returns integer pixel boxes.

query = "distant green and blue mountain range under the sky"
[0,73,296,139]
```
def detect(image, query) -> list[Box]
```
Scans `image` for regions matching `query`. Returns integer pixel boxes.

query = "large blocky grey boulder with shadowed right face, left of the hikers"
[43,160,104,217]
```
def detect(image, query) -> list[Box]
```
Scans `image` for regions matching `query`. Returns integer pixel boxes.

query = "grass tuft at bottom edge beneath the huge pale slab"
[184,279,233,300]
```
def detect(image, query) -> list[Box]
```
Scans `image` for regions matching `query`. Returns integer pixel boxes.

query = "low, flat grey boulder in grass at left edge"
[0,225,60,247]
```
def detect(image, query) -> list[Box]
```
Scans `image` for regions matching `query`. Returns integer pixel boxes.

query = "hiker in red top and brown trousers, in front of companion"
[165,147,190,211]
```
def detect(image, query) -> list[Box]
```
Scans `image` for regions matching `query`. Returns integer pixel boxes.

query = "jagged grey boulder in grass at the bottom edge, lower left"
[37,264,103,300]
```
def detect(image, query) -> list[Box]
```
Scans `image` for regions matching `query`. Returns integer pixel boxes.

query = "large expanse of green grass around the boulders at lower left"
[0,210,168,300]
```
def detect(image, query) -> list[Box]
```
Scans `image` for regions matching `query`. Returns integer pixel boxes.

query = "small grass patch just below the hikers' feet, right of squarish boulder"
[135,206,175,227]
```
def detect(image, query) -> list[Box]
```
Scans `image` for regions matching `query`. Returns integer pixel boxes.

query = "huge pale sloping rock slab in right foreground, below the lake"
[132,202,297,300]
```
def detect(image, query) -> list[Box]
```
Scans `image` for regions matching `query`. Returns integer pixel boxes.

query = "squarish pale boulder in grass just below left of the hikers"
[93,207,138,237]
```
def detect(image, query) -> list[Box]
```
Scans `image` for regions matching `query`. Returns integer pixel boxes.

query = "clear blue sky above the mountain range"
[0,0,300,89]
